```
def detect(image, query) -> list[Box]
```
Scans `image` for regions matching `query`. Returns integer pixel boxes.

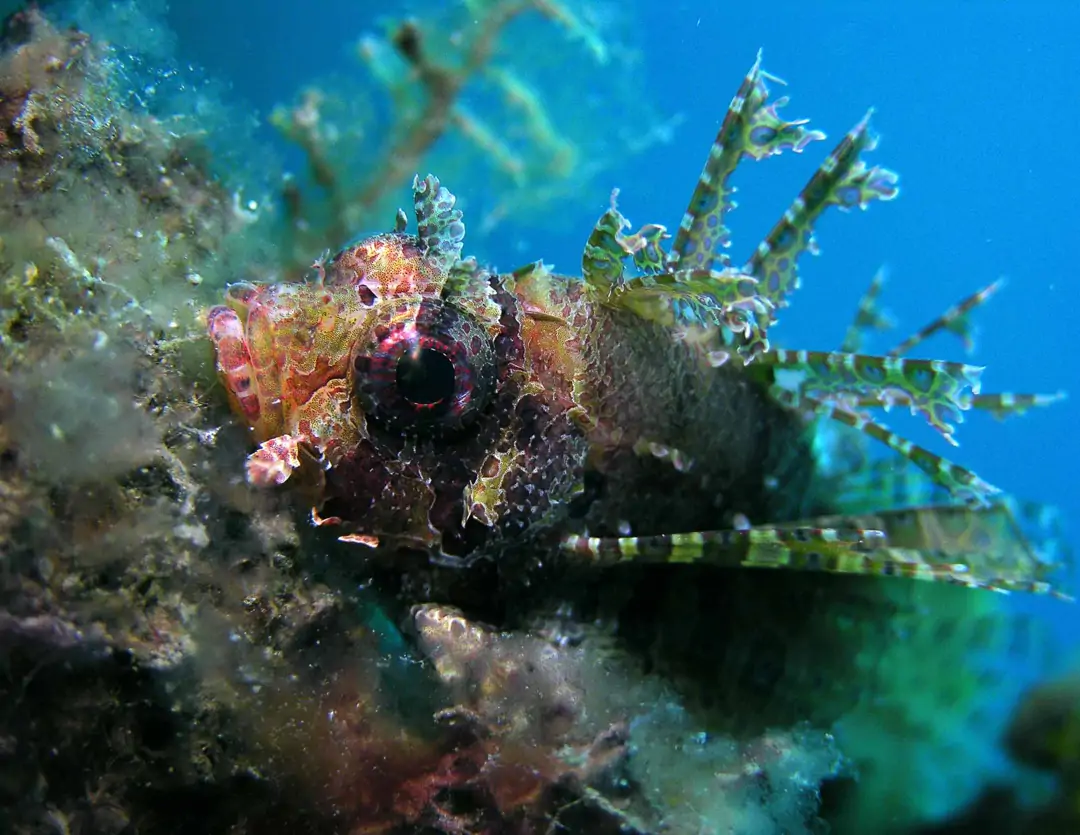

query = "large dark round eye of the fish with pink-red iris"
[353,300,497,433]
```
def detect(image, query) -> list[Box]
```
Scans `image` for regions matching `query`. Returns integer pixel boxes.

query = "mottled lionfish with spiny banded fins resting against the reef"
[208,52,1067,590]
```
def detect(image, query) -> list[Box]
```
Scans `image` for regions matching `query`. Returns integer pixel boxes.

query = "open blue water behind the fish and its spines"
[154,0,1080,635]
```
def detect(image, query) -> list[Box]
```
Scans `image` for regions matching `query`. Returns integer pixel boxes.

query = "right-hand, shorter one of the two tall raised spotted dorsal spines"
[743,113,900,319]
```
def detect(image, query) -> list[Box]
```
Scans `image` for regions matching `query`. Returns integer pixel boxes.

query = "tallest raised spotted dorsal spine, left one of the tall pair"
[671,53,825,270]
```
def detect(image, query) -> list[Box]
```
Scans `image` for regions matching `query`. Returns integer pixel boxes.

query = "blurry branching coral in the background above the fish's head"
[271,0,671,272]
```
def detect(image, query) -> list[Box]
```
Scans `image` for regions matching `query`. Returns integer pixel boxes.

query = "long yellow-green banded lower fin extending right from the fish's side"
[563,527,1066,597]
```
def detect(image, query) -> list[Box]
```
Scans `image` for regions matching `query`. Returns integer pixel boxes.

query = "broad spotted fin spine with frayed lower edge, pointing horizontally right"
[762,350,983,445]
